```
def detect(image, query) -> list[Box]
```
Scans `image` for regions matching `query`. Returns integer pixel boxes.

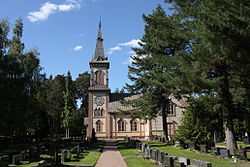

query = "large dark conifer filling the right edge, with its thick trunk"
[166,0,250,152]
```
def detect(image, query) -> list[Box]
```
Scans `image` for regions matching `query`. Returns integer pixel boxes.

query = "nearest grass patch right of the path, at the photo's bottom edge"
[124,157,157,167]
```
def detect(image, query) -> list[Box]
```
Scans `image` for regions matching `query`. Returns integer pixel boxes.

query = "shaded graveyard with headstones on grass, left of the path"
[0,139,105,167]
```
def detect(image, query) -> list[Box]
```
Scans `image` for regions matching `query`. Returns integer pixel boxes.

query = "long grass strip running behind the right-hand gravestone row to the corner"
[145,141,250,167]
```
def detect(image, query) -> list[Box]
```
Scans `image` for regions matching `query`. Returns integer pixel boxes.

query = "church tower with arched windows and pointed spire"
[87,22,111,138]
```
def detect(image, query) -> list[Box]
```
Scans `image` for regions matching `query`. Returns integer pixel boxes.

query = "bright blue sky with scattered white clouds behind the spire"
[0,0,171,91]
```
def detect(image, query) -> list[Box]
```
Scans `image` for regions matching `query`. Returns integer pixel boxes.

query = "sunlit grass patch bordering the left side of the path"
[64,151,101,165]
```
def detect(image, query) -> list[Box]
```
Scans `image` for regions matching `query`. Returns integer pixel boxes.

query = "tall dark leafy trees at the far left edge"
[0,19,47,136]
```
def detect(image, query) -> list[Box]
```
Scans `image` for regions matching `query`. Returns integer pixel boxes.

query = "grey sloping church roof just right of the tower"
[108,93,141,112]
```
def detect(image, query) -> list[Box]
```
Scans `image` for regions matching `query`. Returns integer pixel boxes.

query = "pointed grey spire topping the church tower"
[94,19,106,61]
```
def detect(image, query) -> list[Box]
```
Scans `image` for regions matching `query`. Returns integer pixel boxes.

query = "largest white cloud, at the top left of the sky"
[27,0,81,22]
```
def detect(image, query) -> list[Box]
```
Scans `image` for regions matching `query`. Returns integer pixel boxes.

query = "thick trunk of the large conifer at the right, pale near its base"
[219,62,237,153]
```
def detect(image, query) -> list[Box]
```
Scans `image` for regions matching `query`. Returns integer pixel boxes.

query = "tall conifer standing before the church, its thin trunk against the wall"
[127,5,187,140]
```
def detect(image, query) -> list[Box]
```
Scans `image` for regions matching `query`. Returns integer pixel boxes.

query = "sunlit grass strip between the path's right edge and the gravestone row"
[117,141,157,167]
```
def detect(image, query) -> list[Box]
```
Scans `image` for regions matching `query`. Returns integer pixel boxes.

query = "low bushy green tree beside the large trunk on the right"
[175,96,222,145]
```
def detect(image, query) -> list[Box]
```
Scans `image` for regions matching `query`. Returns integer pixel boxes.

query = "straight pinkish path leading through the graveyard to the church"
[96,140,127,167]
